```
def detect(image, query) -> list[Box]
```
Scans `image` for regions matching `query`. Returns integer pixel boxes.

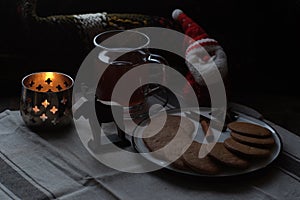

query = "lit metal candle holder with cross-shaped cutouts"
[20,72,74,129]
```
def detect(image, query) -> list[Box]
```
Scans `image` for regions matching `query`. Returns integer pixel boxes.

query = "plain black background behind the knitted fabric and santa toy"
[0,0,300,134]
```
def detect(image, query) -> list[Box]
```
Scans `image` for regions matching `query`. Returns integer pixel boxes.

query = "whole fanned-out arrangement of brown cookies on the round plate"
[143,115,275,175]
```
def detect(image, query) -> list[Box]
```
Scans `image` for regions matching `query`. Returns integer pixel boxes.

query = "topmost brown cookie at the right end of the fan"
[227,122,272,138]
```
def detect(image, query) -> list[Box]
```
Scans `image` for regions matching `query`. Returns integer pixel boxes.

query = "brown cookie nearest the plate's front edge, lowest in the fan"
[182,141,220,175]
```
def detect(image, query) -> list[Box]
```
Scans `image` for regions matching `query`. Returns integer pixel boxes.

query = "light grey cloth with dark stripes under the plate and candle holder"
[0,108,300,200]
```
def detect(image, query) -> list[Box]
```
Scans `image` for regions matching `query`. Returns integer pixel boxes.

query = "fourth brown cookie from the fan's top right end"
[209,142,250,169]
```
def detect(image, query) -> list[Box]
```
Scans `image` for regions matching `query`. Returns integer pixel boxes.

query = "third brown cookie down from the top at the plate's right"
[224,137,271,158]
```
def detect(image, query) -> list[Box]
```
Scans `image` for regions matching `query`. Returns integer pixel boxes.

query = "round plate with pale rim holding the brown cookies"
[132,108,282,177]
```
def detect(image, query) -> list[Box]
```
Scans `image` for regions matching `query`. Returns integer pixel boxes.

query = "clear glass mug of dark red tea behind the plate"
[93,30,168,119]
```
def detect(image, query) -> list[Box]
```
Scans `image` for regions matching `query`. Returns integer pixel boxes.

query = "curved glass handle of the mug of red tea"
[145,54,169,107]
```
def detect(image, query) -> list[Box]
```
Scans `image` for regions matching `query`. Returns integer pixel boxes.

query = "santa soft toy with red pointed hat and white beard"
[172,9,228,106]
